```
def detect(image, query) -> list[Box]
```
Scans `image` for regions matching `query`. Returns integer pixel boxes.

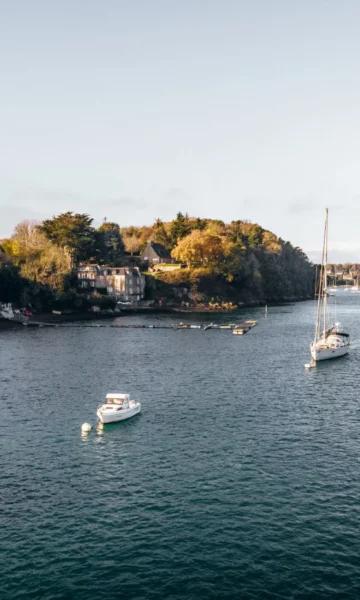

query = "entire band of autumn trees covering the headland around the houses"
[0,212,313,306]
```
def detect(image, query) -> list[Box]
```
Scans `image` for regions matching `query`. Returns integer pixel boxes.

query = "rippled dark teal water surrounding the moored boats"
[0,294,360,600]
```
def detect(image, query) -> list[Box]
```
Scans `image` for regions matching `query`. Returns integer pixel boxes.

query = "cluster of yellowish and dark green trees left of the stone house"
[0,212,125,308]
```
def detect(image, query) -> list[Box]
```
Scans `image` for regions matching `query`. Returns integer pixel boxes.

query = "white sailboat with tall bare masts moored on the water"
[310,209,350,363]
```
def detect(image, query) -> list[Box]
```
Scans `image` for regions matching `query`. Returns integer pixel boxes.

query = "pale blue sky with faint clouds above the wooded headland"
[0,0,360,262]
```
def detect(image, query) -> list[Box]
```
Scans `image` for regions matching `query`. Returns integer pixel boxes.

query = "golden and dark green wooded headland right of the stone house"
[140,213,314,303]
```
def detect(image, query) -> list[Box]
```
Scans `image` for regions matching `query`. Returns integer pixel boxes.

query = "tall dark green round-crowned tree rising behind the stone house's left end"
[39,211,96,266]
